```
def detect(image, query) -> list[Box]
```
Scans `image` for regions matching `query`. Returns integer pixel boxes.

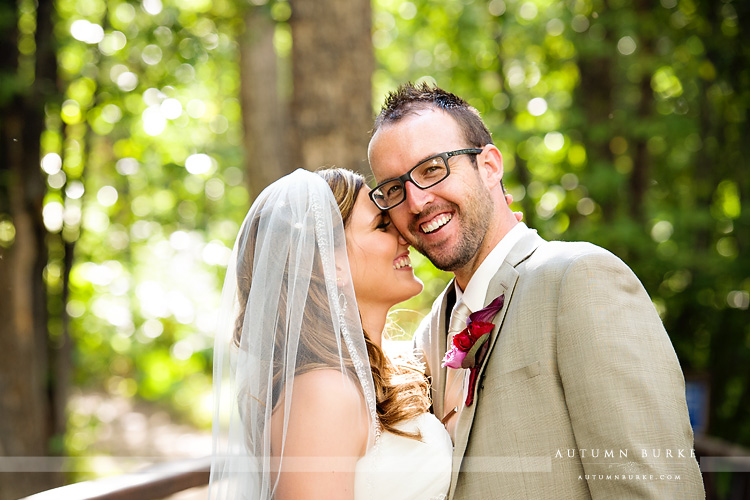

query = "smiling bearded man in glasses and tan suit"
[368,84,704,500]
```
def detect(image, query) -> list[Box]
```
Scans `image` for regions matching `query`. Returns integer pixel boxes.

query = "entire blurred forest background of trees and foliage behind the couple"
[0,0,750,498]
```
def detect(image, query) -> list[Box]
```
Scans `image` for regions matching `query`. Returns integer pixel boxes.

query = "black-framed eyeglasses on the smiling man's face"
[370,148,482,210]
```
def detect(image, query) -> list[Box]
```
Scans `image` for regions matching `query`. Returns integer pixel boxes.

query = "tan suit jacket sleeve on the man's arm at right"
[556,250,705,499]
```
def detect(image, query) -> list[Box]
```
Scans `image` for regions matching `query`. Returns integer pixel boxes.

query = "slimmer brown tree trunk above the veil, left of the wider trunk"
[240,7,294,198]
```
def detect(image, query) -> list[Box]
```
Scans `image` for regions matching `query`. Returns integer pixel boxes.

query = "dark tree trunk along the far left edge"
[0,0,56,499]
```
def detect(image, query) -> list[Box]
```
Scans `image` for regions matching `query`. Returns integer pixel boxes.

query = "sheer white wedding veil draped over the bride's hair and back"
[209,169,379,500]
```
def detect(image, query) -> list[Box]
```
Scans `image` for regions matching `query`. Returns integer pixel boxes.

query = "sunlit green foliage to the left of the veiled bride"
[42,0,249,438]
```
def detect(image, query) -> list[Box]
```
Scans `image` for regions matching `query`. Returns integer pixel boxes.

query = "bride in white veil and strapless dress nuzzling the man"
[210,169,452,500]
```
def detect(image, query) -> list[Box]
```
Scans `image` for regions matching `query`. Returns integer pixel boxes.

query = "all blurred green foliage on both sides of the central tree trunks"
[14,0,750,464]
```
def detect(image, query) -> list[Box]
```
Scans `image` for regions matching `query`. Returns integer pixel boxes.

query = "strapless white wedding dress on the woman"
[354,413,453,500]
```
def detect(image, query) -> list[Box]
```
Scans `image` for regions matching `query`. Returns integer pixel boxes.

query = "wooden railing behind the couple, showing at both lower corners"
[22,436,750,500]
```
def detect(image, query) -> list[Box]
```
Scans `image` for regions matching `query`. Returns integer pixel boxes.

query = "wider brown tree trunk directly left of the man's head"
[289,0,374,175]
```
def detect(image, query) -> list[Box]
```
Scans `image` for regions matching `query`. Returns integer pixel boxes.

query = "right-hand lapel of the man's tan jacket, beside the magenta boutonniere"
[442,231,544,498]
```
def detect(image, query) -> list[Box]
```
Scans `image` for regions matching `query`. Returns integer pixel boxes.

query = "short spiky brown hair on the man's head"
[372,82,492,148]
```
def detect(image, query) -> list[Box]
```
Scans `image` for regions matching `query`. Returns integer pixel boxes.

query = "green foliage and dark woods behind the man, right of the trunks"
[373,0,750,444]
